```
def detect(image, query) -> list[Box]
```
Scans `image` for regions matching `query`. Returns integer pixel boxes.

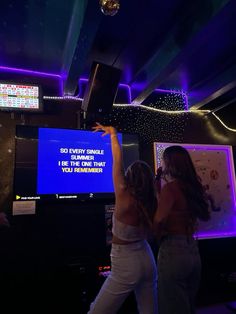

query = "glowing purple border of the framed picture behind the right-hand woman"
[154,143,236,239]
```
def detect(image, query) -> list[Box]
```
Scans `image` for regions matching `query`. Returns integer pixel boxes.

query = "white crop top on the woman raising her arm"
[112,214,147,241]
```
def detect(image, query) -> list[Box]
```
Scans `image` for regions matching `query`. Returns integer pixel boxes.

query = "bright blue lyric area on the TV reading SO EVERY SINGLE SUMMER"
[37,128,122,194]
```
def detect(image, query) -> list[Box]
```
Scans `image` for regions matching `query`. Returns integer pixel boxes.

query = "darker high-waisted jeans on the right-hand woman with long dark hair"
[157,235,201,314]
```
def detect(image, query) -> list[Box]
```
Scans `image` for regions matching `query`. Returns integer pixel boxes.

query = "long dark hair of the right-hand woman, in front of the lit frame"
[163,145,210,221]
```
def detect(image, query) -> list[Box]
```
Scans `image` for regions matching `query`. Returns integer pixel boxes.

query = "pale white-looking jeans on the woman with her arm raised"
[88,241,157,314]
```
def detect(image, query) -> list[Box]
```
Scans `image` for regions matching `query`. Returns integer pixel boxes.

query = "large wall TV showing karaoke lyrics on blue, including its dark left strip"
[14,125,139,201]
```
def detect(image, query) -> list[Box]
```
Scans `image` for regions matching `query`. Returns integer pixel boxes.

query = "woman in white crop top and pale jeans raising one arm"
[88,123,157,314]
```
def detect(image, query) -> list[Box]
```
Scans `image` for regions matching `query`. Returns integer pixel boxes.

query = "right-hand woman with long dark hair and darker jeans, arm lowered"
[154,145,210,314]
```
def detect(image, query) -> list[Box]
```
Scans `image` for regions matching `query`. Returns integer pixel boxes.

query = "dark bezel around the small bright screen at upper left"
[0,80,44,113]
